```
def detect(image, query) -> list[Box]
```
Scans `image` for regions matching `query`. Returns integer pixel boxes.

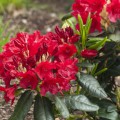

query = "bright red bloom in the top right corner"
[107,0,120,22]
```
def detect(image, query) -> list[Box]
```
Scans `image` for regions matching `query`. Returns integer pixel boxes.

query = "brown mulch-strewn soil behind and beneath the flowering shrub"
[0,0,71,120]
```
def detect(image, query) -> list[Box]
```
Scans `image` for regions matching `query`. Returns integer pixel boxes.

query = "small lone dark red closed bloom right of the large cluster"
[81,49,98,59]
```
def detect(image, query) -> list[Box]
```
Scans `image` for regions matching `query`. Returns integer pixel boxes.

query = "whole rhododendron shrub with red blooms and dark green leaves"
[0,0,120,120]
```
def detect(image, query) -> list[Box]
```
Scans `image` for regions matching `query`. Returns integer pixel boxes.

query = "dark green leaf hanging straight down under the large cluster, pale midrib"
[34,95,55,120]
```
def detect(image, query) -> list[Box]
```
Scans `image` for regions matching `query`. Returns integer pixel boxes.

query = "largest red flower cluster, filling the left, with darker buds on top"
[0,27,78,101]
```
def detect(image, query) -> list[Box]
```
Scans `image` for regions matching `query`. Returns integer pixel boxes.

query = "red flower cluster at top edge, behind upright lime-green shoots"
[72,0,106,32]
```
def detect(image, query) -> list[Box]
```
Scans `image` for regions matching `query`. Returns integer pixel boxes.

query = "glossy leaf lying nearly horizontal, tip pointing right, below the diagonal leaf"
[62,95,99,112]
